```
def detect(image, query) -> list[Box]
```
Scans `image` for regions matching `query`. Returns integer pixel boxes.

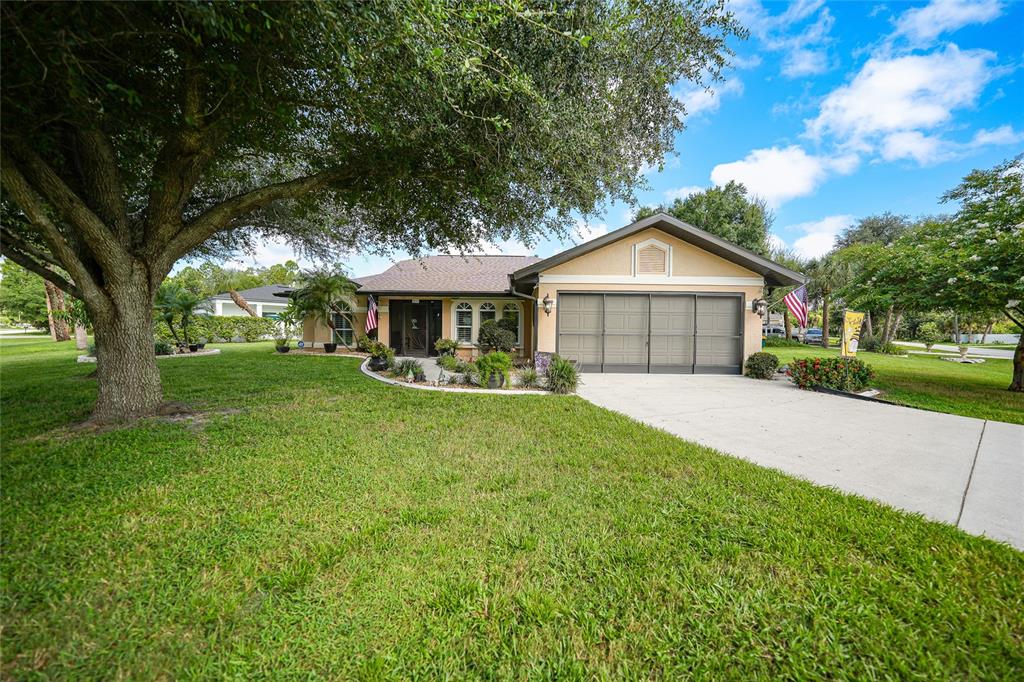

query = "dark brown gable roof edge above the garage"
[512,213,807,287]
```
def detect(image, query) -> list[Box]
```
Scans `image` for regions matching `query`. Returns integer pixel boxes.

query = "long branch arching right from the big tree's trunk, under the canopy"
[154,171,344,270]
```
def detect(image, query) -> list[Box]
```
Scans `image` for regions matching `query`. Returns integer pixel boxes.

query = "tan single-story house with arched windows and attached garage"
[303,213,805,374]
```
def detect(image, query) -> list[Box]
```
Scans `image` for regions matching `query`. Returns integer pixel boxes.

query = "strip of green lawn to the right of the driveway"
[765,346,1024,424]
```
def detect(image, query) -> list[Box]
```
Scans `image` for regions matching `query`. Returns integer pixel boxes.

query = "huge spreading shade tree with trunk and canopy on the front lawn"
[0,0,743,420]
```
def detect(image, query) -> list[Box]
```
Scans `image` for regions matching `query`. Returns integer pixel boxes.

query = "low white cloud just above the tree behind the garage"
[711,144,859,207]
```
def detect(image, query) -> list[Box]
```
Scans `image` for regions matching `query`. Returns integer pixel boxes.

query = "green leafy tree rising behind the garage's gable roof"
[636,181,775,256]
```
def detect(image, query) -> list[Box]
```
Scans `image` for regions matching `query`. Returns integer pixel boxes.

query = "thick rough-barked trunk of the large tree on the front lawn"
[90,269,163,422]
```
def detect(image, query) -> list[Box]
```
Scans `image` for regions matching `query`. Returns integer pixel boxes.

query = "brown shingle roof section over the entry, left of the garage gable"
[354,254,540,294]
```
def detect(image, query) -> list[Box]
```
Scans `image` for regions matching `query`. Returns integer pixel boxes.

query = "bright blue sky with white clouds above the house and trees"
[235,0,1024,275]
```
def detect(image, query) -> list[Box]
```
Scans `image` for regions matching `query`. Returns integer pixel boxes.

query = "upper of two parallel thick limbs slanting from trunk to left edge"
[4,141,130,280]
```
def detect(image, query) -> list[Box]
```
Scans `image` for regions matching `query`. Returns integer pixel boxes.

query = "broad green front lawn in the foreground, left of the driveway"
[6,340,1024,680]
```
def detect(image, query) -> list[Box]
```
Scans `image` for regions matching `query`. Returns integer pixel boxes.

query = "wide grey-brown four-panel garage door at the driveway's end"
[558,294,743,374]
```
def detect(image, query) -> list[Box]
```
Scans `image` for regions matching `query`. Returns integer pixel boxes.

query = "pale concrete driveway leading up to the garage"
[580,374,1024,550]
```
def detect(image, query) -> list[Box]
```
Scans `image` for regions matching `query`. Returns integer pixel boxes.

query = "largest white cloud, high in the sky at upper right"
[806,45,995,151]
